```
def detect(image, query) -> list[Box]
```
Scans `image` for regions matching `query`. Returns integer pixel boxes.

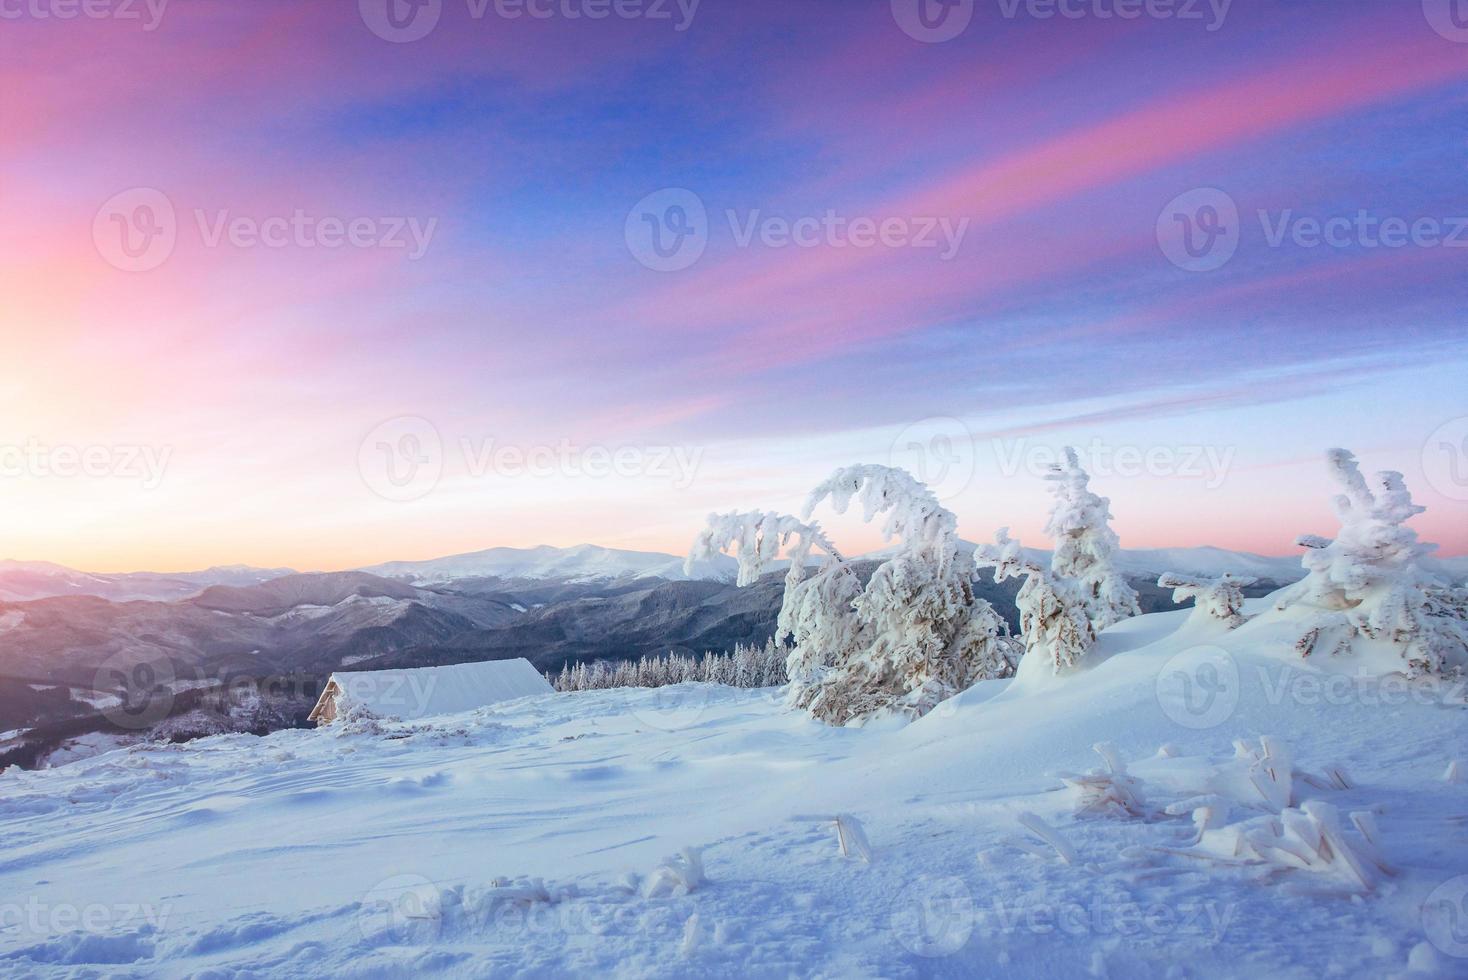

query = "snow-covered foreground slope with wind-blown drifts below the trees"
[0,613,1468,977]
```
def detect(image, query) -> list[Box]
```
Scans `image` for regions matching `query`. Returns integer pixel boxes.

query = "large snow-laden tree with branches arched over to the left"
[688,465,1016,725]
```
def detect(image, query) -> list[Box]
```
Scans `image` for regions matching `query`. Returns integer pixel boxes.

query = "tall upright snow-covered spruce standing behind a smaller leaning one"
[1045,446,1142,632]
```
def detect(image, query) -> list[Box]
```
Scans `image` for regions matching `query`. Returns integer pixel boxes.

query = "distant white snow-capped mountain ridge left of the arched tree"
[363,544,735,584]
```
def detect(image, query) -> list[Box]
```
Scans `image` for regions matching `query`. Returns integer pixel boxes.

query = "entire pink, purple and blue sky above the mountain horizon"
[0,0,1468,572]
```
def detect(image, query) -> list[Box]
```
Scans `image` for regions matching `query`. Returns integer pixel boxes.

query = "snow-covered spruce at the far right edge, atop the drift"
[1276,449,1468,676]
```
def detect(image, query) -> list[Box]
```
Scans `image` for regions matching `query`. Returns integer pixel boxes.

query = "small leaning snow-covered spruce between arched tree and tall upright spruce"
[973,528,1097,673]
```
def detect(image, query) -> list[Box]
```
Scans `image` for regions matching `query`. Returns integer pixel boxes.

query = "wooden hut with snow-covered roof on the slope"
[308,657,553,725]
